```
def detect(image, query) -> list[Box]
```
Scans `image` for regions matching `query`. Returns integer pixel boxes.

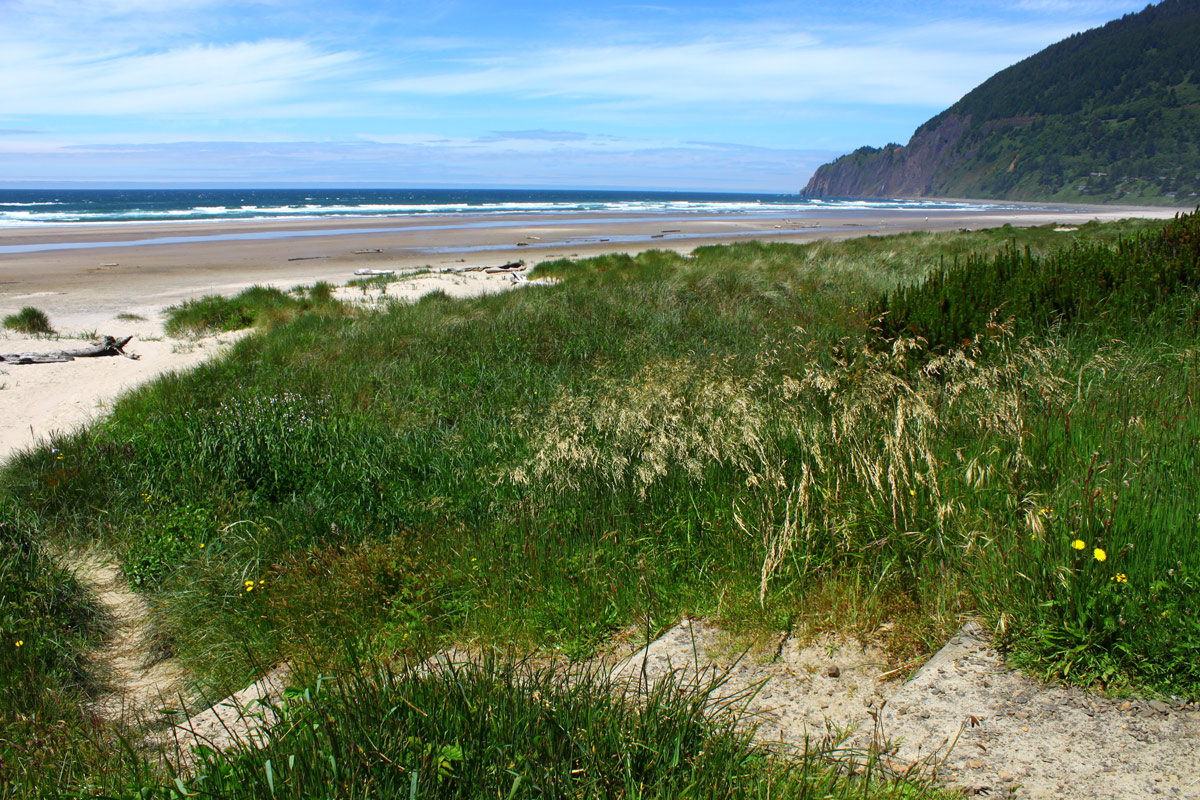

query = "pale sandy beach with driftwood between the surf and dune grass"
[0,205,1177,461]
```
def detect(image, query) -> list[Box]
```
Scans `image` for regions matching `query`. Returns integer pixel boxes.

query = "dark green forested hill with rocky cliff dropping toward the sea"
[803,0,1200,205]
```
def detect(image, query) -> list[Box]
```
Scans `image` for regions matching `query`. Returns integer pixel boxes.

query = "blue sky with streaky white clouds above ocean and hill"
[0,0,1161,193]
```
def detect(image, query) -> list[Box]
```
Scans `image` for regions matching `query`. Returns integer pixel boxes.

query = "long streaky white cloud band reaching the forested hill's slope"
[376,24,1089,107]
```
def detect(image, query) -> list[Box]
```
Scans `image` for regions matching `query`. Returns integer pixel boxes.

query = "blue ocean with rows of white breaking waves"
[0,188,1013,228]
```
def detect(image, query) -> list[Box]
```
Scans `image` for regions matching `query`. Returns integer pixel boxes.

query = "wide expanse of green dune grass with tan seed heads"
[4,215,1200,796]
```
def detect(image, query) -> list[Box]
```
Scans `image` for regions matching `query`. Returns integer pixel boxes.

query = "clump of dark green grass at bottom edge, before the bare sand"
[140,658,935,800]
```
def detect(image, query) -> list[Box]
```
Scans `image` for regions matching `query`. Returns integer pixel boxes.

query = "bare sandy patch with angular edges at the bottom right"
[613,620,1200,800]
